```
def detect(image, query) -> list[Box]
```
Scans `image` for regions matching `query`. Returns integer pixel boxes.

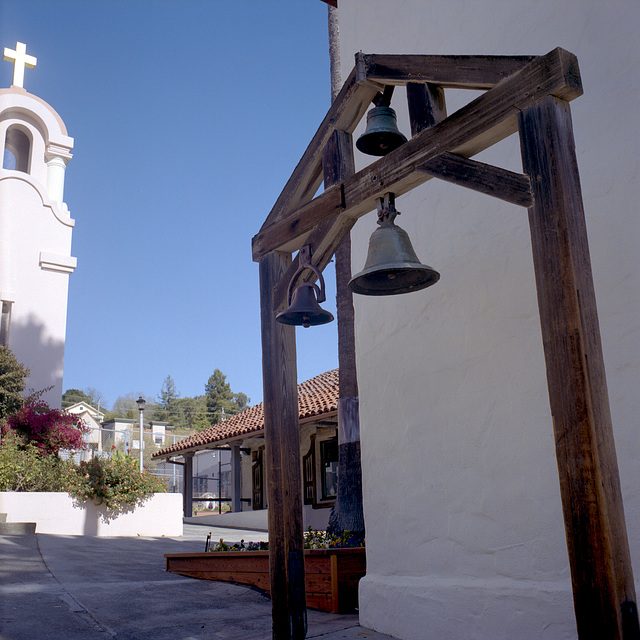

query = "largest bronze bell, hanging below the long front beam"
[349,194,440,296]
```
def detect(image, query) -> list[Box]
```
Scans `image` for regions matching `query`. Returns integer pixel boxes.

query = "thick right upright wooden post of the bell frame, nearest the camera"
[518,96,640,640]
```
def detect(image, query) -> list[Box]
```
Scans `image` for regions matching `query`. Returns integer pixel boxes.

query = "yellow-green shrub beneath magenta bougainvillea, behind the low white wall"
[0,433,75,491]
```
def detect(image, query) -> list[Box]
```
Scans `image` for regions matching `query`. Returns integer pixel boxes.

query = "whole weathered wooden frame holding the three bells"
[252,48,640,640]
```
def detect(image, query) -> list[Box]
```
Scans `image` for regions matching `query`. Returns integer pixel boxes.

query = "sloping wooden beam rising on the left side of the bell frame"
[261,69,380,230]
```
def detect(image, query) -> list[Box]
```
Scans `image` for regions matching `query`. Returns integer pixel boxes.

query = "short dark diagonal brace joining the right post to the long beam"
[419,152,533,207]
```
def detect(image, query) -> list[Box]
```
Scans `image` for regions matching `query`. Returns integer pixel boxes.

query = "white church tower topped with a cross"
[0,43,76,407]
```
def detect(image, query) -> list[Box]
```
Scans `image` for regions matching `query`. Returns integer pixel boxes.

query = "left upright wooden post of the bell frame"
[260,252,307,640]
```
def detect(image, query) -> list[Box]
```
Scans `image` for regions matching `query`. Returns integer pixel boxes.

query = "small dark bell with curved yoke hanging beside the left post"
[276,245,333,328]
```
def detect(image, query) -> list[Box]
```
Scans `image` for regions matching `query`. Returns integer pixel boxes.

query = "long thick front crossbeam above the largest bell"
[253,49,582,260]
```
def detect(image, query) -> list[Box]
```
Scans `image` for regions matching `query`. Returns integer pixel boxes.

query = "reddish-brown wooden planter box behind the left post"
[164,548,366,613]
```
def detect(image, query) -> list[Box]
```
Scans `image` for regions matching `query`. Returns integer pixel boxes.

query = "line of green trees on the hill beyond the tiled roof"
[62,369,251,433]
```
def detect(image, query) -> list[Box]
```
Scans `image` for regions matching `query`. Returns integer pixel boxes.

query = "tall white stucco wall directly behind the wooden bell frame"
[339,0,640,640]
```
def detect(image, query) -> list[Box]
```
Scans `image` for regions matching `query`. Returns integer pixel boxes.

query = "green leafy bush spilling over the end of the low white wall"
[69,451,167,511]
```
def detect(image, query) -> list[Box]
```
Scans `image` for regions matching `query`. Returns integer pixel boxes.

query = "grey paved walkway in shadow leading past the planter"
[0,525,396,640]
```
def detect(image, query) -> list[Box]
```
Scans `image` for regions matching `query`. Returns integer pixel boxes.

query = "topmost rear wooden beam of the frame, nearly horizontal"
[356,53,537,89]
